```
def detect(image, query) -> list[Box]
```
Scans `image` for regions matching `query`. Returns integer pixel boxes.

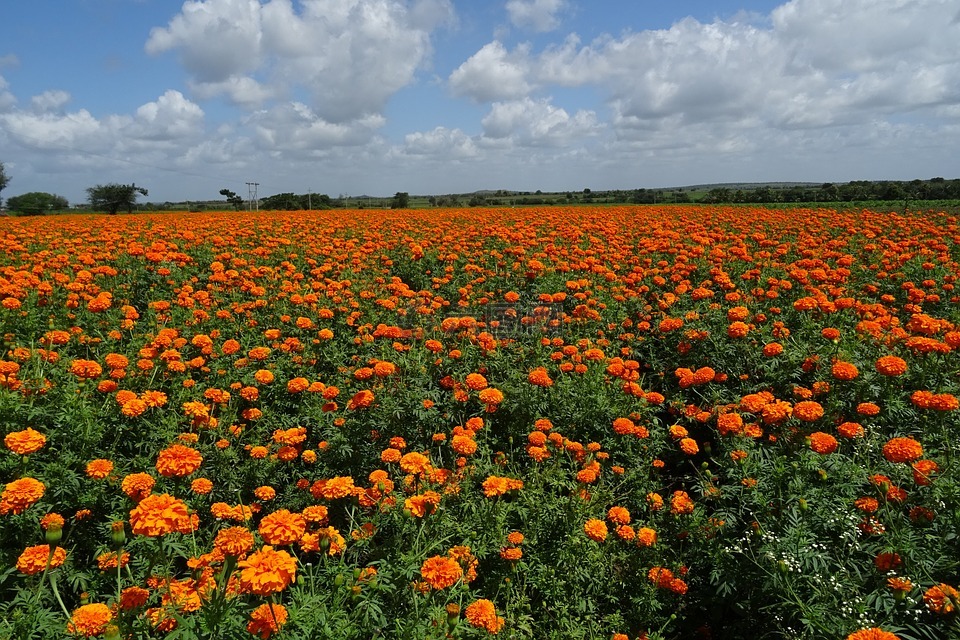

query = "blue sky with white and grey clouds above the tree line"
[0,0,960,202]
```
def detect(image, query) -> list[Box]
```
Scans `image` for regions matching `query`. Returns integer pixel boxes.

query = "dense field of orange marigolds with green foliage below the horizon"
[0,207,960,640]
